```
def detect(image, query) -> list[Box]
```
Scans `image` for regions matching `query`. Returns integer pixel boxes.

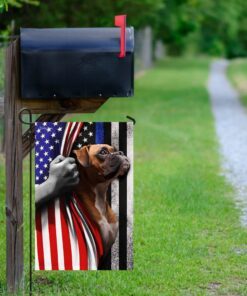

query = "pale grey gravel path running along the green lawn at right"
[208,60,247,227]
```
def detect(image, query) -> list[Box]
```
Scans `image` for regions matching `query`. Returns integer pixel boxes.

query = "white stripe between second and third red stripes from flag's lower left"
[54,198,64,270]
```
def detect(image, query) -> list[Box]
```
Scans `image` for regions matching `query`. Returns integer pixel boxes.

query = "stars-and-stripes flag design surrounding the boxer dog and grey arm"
[35,122,133,270]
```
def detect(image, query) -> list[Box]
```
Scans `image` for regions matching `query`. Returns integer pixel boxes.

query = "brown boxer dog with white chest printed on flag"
[73,144,130,256]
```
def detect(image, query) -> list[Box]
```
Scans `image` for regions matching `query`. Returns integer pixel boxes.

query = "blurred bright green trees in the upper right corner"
[156,0,247,57]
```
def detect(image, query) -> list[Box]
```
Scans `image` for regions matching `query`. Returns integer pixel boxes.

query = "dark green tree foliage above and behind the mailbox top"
[1,0,163,28]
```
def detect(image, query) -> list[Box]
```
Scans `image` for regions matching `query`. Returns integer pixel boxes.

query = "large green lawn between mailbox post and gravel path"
[0,59,247,296]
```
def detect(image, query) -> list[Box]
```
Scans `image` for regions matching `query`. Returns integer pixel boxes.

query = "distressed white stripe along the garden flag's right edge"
[127,122,134,269]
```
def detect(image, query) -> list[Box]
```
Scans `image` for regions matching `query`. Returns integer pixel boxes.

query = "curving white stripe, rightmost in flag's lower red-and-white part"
[73,199,98,270]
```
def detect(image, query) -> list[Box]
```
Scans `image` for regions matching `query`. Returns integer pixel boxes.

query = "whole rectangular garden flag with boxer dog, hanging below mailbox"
[35,122,133,270]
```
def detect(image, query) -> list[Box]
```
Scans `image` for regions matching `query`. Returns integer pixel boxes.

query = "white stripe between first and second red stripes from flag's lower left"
[41,208,52,270]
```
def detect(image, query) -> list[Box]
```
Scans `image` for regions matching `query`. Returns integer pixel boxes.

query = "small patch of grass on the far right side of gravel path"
[228,59,247,107]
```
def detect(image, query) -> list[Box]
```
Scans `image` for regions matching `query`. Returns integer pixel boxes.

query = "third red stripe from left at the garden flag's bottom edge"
[60,198,72,270]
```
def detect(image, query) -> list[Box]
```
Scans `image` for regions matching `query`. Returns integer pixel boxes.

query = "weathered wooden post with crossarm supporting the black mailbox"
[4,39,107,292]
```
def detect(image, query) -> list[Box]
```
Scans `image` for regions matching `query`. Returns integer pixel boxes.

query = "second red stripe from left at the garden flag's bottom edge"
[48,201,58,270]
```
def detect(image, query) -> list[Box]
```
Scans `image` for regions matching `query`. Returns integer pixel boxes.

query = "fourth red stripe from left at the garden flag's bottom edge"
[70,200,88,270]
